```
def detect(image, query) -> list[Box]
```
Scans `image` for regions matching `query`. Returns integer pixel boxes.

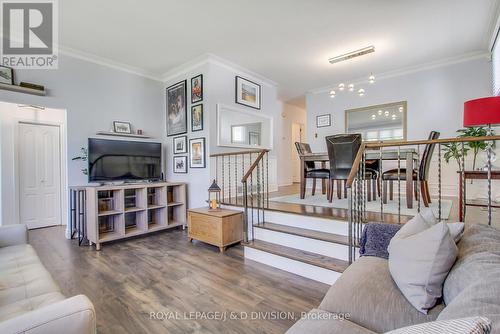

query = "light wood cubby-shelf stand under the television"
[78,182,187,250]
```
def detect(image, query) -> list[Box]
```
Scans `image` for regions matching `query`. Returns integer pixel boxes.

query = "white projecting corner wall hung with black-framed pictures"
[164,61,291,207]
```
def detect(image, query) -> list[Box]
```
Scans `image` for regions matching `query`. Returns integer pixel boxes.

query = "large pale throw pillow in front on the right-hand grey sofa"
[387,219,458,314]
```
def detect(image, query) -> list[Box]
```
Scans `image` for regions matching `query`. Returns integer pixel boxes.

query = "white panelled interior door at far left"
[17,123,61,228]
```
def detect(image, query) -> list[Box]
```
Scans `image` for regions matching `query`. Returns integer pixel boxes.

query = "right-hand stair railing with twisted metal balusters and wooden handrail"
[346,136,500,263]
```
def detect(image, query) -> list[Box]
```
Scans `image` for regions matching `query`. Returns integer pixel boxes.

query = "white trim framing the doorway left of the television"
[13,117,69,230]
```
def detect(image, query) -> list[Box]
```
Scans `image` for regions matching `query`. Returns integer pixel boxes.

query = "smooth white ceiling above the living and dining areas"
[59,0,500,100]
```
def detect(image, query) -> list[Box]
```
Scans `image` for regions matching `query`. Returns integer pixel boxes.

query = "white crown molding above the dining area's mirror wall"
[306,51,491,94]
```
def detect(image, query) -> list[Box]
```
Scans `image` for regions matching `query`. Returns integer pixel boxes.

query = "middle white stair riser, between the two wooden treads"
[254,227,356,261]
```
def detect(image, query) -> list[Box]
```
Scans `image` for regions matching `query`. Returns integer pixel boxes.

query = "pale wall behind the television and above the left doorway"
[0,54,165,224]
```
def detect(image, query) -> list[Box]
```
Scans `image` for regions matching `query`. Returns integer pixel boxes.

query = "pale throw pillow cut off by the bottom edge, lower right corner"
[385,317,491,334]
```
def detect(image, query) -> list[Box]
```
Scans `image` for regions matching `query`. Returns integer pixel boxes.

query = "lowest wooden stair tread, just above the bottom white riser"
[247,240,349,273]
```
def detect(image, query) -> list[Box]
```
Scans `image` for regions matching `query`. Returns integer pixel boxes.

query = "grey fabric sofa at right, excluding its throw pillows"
[287,225,500,334]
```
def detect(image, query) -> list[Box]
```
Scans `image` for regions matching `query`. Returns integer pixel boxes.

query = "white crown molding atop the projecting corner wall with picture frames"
[162,53,278,87]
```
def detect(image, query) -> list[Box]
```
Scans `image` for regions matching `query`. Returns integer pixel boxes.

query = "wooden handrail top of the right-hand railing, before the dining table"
[346,135,500,188]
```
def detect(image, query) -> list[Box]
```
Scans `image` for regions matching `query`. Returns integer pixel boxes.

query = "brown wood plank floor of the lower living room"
[30,227,329,334]
